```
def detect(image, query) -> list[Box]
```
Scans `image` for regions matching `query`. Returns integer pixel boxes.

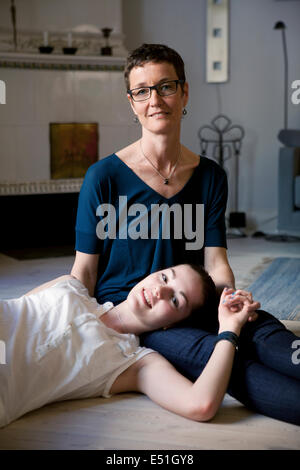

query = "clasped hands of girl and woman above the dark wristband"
[219,288,260,334]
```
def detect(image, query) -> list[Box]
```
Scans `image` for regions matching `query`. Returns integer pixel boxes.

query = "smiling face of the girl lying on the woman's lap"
[127,264,203,331]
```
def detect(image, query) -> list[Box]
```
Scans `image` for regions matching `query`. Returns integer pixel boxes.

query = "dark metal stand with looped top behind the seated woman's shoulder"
[198,114,246,238]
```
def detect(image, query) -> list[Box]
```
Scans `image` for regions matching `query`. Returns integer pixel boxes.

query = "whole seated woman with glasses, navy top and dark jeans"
[72,44,300,424]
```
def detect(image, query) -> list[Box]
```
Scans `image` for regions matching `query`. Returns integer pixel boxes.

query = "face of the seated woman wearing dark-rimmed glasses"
[128,62,188,133]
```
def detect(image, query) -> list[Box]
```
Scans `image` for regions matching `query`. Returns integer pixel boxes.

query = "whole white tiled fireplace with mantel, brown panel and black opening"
[0,35,132,252]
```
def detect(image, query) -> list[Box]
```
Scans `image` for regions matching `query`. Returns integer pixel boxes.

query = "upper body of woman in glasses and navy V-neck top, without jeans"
[72,45,234,302]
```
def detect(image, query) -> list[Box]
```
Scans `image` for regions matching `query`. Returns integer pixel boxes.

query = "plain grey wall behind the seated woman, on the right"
[123,0,300,231]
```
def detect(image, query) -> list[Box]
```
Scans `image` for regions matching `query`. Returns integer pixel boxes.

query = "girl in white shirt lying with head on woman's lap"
[0,265,258,426]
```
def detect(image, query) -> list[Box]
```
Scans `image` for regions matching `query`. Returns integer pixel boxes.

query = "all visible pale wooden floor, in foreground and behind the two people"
[0,239,300,450]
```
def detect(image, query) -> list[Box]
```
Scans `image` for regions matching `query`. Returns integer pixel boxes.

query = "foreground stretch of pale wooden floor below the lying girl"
[0,394,300,450]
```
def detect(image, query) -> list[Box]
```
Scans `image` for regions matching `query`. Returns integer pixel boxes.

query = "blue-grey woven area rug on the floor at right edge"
[247,258,300,320]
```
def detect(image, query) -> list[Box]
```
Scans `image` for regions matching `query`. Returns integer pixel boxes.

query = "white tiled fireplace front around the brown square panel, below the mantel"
[0,69,139,181]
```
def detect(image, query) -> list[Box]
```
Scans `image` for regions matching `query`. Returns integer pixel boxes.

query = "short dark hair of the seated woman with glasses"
[124,44,186,90]
